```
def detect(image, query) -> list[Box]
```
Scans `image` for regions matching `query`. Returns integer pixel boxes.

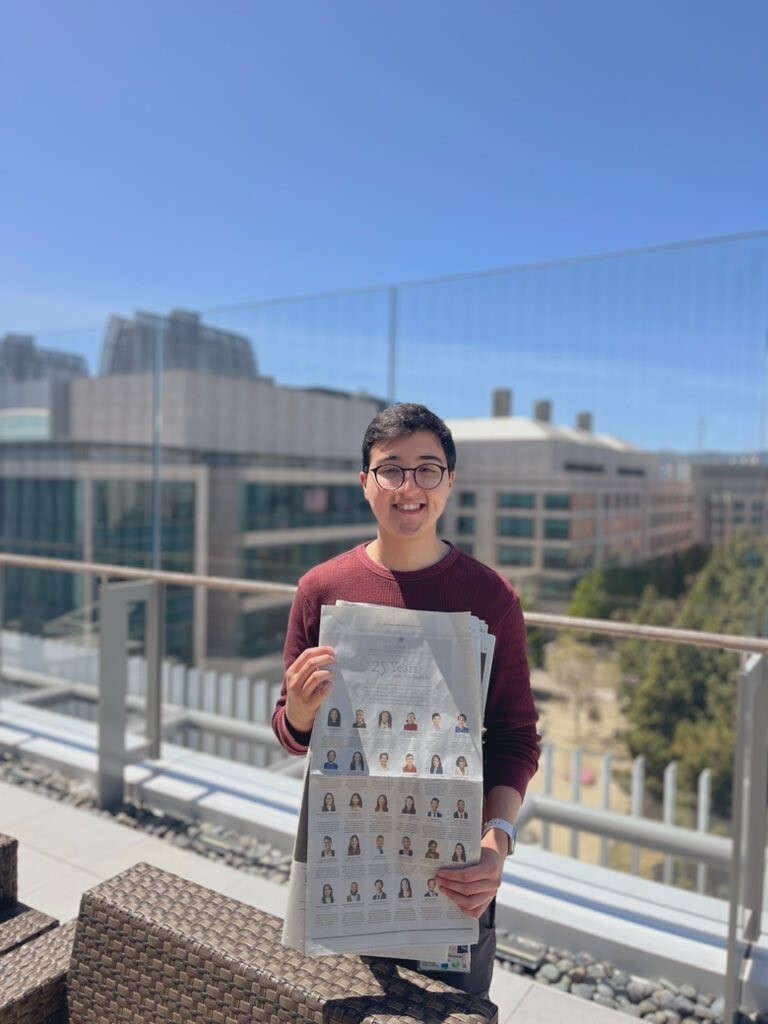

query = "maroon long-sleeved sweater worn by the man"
[272,544,539,796]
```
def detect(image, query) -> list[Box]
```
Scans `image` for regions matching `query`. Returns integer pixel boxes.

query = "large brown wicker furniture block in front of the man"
[69,864,497,1024]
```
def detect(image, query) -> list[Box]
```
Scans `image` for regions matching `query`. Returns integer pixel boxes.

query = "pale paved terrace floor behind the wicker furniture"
[0,782,627,1024]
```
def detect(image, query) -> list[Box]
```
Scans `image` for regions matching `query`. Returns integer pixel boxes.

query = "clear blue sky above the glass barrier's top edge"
[0,0,768,443]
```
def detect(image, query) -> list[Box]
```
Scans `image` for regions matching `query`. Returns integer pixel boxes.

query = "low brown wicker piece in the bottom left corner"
[0,921,75,1024]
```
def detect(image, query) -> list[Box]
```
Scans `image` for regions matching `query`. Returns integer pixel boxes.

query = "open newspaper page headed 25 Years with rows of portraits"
[284,603,494,963]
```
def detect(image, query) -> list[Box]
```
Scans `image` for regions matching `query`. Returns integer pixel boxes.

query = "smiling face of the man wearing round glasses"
[360,430,456,542]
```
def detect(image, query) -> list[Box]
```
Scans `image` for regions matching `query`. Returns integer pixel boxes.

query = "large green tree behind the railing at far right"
[621,534,768,814]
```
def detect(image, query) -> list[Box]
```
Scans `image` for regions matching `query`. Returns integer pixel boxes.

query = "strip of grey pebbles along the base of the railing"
[0,754,768,1024]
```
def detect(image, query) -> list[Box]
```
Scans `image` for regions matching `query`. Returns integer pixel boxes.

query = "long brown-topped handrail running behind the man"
[0,553,768,654]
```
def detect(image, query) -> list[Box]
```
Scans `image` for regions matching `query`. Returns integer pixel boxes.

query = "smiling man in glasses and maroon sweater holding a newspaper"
[272,404,539,995]
